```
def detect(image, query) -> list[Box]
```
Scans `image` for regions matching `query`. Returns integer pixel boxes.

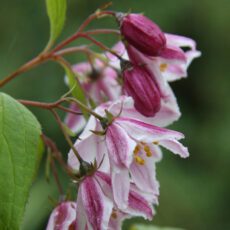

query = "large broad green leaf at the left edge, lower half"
[0,93,43,230]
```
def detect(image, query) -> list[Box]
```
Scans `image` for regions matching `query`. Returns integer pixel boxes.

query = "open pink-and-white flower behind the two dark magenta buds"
[107,34,201,123]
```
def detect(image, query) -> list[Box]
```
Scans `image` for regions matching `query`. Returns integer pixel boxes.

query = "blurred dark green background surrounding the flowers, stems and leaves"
[0,0,230,230]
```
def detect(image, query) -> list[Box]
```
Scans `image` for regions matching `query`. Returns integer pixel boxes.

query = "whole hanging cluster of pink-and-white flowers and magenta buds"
[47,13,200,230]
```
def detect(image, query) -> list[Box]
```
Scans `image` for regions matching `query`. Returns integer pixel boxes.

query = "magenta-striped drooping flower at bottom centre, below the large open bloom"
[62,159,156,230]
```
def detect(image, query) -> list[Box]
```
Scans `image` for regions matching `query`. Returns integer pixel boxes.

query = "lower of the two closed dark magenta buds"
[123,66,161,117]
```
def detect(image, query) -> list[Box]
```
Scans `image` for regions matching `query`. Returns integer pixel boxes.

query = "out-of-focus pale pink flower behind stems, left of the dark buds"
[65,59,121,133]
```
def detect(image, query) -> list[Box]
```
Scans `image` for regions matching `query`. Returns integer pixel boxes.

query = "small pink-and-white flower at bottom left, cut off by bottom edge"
[46,201,78,230]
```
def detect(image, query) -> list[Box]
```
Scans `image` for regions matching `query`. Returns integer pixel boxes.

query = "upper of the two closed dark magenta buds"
[120,14,166,56]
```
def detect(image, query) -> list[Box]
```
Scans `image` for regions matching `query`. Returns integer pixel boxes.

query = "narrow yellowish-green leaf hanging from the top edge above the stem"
[46,0,67,49]
